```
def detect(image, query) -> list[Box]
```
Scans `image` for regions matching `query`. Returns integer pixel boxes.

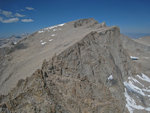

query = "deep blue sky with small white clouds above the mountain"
[0,0,150,37]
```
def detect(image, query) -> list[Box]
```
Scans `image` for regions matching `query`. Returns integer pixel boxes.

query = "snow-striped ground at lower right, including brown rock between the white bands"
[124,73,150,113]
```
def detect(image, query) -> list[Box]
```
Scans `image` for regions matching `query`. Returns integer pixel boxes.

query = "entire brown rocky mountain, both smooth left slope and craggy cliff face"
[0,19,149,113]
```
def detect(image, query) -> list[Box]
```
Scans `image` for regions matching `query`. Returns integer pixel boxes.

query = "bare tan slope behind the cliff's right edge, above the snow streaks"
[120,35,150,75]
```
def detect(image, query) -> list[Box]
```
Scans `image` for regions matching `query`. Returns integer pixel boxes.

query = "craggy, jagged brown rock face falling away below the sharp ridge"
[0,20,134,113]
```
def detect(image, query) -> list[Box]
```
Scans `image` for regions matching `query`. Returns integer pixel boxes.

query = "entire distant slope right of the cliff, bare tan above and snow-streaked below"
[120,35,150,113]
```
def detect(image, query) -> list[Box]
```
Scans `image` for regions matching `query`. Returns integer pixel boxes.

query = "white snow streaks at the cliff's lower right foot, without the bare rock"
[124,73,150,113]
